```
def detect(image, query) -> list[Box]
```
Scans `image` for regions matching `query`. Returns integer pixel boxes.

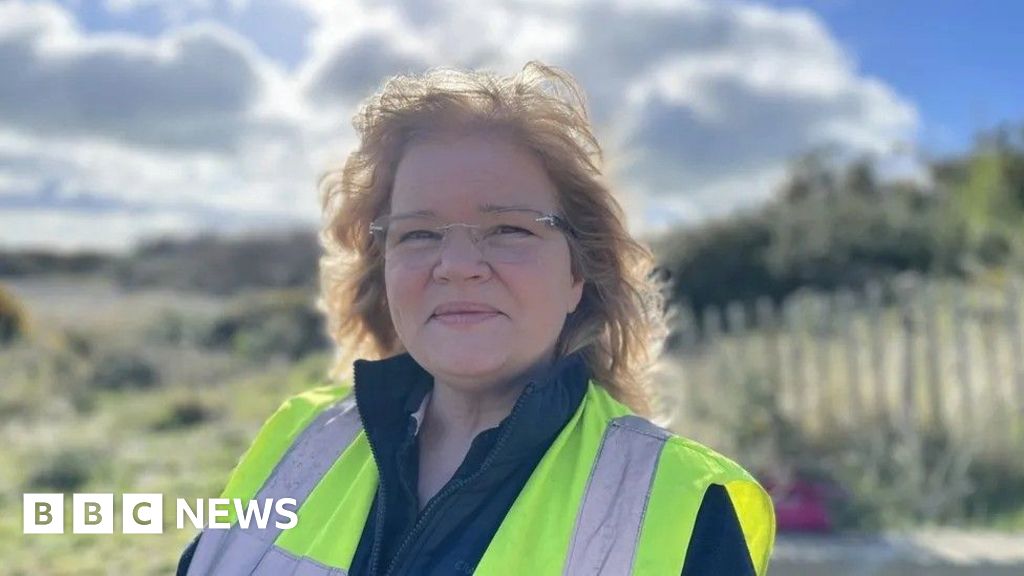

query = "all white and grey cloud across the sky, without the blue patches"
[0,0,916,251]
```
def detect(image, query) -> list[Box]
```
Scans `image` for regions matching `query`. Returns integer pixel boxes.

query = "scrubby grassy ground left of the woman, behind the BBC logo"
[0,280,328,576]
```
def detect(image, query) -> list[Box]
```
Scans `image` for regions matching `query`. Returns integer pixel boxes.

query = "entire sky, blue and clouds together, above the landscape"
[0,0,1024,250]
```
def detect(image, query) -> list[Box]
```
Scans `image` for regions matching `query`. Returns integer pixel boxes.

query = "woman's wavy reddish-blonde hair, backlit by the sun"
[318,61,666,414]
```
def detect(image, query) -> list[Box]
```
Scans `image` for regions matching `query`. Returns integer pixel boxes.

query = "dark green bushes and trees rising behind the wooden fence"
[653,122,1024,314]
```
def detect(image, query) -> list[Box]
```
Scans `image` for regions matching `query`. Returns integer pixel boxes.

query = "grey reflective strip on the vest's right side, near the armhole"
[564,415,671,576]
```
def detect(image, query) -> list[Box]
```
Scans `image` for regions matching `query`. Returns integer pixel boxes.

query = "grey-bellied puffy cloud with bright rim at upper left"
[0,3,272,150]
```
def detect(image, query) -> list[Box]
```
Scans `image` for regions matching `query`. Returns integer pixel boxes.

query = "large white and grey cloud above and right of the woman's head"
[295,0,916,225]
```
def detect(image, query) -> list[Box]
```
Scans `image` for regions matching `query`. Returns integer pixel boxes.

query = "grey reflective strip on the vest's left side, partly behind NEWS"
[187,397,362,576]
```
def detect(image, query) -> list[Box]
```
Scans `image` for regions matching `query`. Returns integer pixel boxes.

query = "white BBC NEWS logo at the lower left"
[23,494,299,534]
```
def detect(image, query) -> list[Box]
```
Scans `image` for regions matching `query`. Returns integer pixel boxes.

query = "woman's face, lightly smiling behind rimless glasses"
[384,134,583,392]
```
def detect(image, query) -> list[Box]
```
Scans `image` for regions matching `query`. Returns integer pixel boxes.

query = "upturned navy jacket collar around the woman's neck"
[354,354,590,474]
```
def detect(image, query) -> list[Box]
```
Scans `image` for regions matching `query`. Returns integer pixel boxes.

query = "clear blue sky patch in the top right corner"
[770,0,1024,154]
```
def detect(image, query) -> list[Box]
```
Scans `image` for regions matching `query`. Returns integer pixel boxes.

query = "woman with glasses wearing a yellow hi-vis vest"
[179,63,774,576]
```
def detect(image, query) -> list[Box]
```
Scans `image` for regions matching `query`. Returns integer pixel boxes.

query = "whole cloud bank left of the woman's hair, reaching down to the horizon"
[0,3,316,248]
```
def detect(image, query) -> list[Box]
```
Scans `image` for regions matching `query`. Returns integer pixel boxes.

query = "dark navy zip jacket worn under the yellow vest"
[178,355,755,576]
